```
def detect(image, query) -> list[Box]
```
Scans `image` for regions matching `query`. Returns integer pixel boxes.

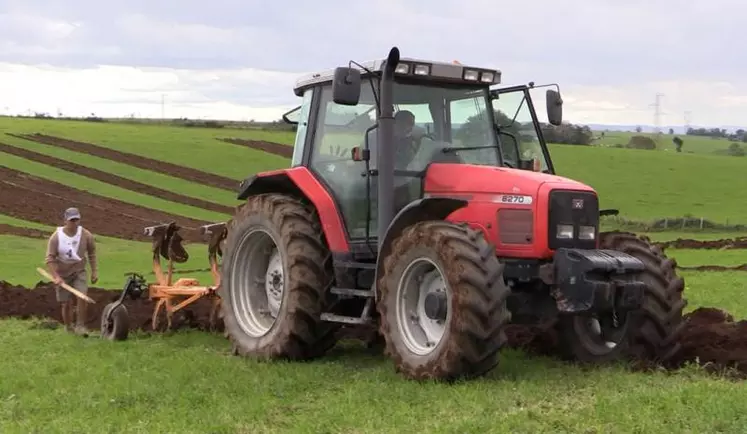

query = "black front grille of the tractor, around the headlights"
[547,190,599,250]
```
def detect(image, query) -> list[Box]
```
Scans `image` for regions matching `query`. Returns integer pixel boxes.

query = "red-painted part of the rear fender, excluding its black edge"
[256,167,350,252]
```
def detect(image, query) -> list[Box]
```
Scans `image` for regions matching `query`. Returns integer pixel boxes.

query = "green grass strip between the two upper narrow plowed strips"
[0,136,237,205]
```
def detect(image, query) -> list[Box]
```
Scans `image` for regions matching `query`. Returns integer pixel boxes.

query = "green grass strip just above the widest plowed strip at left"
[0,152,226,221]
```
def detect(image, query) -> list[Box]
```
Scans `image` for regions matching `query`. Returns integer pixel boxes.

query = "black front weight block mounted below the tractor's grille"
[552,248,646,314]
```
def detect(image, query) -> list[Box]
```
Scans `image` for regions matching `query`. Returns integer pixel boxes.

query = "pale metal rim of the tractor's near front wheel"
[396,258,451,356]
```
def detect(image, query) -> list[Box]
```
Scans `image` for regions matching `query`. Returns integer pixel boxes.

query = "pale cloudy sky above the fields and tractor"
[0,0,747,126]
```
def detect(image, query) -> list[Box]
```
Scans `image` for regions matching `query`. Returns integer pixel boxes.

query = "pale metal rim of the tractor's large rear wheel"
[229,229,285,337]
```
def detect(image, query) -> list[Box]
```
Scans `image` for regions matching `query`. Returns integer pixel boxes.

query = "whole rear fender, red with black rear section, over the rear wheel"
[237,167,350,253]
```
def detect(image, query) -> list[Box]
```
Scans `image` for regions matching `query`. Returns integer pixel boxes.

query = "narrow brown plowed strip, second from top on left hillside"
[0,143,233,215]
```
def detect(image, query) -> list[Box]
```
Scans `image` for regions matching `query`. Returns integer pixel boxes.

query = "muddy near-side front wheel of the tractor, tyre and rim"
[377,221,510,381]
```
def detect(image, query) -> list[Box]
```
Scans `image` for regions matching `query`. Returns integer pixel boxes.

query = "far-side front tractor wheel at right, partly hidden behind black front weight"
[559,232,687,364]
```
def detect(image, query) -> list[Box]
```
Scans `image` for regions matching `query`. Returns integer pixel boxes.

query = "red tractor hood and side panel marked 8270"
[424,163,596,258]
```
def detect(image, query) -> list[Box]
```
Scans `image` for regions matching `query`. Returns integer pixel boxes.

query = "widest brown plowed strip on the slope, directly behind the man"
[0,166,208,242]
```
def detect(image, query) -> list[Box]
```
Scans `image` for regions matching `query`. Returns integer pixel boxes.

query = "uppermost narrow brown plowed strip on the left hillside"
[6,133,239,191]
